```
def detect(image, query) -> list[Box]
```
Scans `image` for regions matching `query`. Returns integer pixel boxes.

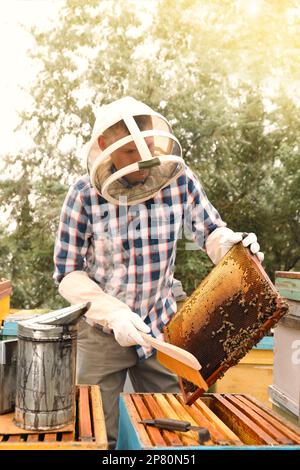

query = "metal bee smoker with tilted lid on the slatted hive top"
[15,303,90,431]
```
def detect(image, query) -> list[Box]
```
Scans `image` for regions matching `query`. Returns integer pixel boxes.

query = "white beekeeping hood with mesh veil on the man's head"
[84,97,184,205]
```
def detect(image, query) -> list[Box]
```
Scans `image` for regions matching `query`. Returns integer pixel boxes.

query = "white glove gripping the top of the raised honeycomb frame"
[205,227,264,264]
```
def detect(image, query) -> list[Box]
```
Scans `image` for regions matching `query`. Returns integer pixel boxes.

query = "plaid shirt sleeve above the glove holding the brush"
[53,187,90,284]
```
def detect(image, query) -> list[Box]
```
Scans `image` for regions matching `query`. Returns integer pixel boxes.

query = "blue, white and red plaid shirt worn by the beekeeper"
[54,167,226,359]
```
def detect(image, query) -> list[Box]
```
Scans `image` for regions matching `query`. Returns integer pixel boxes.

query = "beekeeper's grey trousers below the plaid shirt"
[77,320,180,448]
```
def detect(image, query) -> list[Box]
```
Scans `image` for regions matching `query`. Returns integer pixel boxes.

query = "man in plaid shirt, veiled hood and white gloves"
[54,97,263,448]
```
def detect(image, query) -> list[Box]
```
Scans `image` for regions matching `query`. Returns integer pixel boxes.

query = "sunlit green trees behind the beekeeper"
[0,0,300,308]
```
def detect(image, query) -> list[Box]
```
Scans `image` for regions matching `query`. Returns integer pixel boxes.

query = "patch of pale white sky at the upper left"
[0,0,63,159]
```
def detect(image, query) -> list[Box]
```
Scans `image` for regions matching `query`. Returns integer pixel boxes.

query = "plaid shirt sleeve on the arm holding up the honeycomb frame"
[184,168,226,250]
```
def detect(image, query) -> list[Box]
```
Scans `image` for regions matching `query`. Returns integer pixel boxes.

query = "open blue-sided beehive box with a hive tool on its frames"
[117,393,300,451]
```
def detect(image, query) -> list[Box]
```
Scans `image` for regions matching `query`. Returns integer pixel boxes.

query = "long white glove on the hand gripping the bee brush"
[58,271,151,349]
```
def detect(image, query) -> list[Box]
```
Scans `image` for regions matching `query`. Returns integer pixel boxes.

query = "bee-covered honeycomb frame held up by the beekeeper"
[164,243,288,404]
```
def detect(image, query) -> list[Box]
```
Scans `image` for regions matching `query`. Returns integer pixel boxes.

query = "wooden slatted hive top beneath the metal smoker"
[0,385,108,450]
